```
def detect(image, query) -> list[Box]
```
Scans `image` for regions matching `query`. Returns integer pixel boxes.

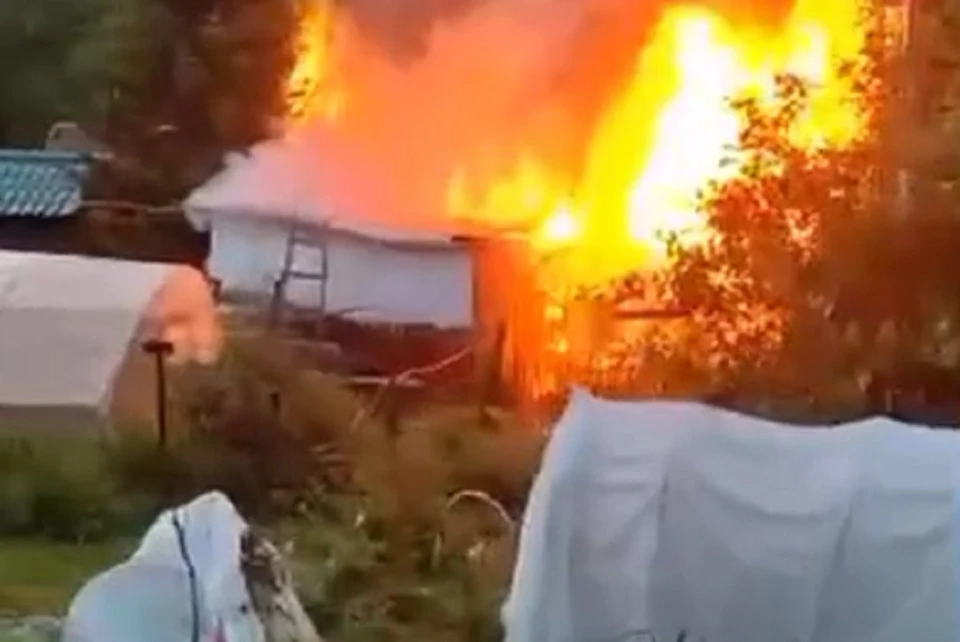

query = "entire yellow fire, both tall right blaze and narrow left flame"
[291,0,884,398]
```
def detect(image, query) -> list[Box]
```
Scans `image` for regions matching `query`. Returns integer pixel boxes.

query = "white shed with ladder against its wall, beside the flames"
[184,148,484,328]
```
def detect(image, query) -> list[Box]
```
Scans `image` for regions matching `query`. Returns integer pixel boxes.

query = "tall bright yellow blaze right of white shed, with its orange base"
[448,0,866,396]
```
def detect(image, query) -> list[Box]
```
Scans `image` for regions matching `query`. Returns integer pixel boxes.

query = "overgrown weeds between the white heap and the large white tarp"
[274,390,543,642]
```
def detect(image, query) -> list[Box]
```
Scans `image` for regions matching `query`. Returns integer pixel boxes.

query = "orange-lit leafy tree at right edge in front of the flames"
[620,0,960,418]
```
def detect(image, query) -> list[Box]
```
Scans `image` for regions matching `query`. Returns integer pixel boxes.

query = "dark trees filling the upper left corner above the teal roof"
[0,0,298,201]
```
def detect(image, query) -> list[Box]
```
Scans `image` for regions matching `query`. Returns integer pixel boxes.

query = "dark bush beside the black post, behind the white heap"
[111,341,348,520]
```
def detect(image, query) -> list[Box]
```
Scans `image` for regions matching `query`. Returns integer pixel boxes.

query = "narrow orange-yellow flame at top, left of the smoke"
[286,0,346,125]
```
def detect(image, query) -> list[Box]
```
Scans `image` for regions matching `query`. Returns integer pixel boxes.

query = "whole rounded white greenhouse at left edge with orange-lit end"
[0,251,221,430]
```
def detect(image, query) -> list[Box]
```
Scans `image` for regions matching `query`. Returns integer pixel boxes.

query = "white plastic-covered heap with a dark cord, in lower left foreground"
[63,493,318,642]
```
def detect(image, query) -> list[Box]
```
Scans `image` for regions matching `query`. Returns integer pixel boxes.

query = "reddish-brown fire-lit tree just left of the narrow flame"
[99,0,298,202]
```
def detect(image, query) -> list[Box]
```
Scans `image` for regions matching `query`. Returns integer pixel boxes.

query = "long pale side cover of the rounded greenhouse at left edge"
[0,251,176,407]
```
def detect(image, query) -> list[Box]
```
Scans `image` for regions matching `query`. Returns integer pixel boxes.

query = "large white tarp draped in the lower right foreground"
[504,393,960,642]
